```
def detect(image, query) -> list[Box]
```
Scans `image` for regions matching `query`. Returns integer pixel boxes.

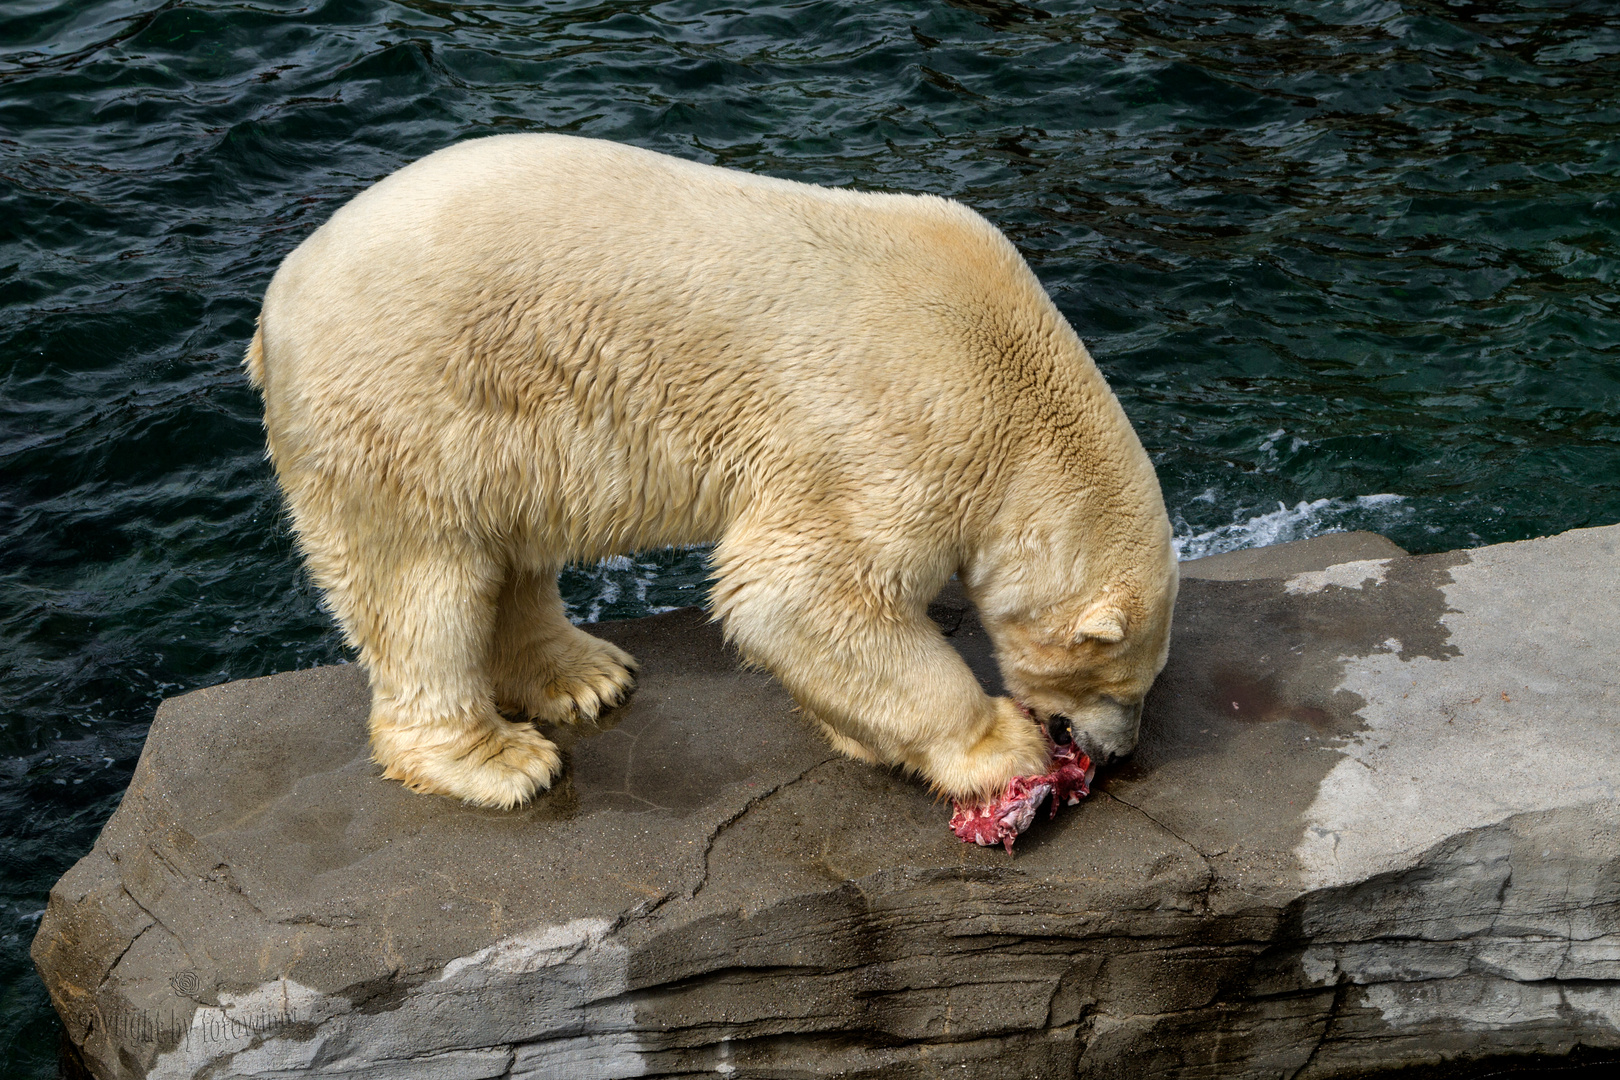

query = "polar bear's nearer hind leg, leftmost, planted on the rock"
[328,533,562,810]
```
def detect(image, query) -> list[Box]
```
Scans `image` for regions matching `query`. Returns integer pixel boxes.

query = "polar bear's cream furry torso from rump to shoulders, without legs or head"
[261,134,1150,557]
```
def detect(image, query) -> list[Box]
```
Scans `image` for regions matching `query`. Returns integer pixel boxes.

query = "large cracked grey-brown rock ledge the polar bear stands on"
[34,526,1620,1080]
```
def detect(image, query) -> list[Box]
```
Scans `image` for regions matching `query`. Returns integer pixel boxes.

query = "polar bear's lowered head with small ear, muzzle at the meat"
[985,560,1178,764]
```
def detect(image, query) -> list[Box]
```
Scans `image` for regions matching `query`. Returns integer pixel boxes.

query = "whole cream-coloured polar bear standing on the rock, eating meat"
[246,134,1178,808]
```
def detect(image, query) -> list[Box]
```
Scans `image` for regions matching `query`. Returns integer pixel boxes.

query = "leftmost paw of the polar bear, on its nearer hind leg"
[371,717,562,810]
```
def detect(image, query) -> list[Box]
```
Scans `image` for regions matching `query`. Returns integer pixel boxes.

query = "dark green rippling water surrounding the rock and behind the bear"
[0,0,1620,1077]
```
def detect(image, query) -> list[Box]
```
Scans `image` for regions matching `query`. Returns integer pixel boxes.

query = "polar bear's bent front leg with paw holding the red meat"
[713,531,1048,798]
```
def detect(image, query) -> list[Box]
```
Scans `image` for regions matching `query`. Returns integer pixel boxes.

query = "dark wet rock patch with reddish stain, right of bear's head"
[1100,552,1468,904]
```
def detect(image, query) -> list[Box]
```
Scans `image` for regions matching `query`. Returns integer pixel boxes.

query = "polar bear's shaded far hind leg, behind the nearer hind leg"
[491,568,637,724]
